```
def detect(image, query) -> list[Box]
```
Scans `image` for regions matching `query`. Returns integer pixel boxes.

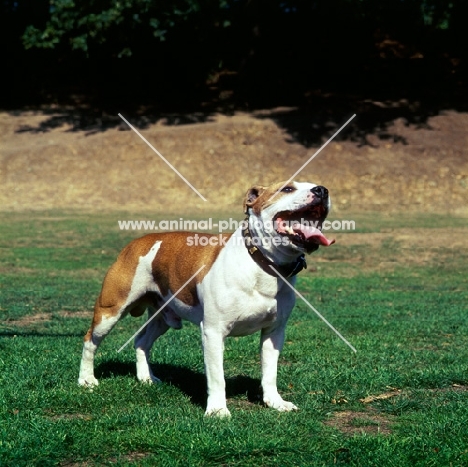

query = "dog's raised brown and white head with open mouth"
[244,182,334,255]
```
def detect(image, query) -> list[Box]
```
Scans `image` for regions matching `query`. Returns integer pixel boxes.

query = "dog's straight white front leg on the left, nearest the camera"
[201,323,231,417]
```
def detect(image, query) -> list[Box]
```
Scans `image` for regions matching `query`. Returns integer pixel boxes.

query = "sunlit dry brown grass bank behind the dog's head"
[0,112,468,214]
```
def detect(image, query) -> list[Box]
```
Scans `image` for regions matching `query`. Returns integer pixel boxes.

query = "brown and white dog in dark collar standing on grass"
[78,182,333,416]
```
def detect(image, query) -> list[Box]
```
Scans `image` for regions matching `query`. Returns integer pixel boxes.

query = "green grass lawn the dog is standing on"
[0,213,468,467]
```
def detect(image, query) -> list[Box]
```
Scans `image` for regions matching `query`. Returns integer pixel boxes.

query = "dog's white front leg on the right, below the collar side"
[261,327,297,412]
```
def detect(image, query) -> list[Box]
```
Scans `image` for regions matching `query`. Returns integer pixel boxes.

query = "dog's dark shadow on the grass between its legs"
[95,360,262,408]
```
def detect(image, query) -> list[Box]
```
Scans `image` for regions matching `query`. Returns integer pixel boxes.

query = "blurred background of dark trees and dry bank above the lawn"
[0,0,468,212]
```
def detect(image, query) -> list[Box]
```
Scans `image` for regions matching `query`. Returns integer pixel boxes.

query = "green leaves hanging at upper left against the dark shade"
[22,0,233,57]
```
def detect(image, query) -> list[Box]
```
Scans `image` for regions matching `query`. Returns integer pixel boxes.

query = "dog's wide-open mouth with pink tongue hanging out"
[273,204,335,253]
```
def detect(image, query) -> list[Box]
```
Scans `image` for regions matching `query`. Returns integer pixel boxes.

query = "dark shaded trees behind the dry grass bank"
[0,0,468,109]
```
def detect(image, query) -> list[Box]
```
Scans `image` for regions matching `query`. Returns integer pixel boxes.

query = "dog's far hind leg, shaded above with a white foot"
[135,306,169,383]
